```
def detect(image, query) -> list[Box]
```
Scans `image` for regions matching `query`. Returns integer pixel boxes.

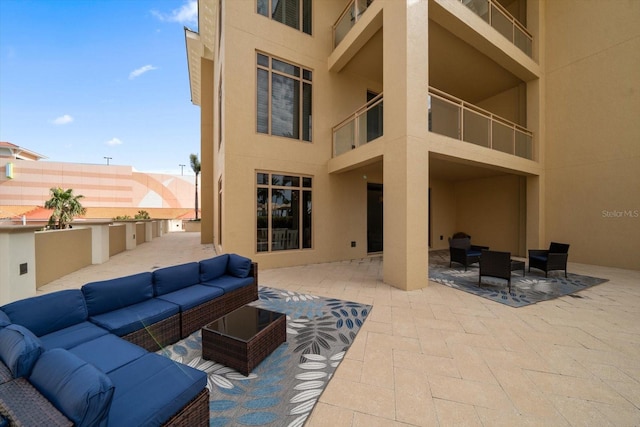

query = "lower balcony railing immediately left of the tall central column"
[333,93,383,157]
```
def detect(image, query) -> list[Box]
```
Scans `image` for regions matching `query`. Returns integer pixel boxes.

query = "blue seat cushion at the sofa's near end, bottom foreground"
[109,353,207,427]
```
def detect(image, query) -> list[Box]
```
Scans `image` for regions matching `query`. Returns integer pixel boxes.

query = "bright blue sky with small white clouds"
[0,0,200,175]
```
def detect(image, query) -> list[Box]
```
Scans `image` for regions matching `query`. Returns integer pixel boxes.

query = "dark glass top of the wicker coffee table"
[204,305,284,341]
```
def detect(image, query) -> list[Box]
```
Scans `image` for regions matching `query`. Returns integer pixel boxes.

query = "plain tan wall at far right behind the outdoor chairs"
[545,0,640,269]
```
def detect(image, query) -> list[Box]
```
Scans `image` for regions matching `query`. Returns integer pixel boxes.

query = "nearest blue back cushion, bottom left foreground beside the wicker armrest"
[29,348,114,427]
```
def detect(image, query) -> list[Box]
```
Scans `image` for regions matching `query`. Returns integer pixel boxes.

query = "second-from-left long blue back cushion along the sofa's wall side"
[82,272,153,316]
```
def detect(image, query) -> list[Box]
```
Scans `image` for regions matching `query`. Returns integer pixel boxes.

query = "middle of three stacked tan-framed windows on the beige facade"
[256,53,312,142]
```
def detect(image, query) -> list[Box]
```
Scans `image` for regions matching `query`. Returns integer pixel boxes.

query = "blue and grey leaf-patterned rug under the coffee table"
[158,286,372,427]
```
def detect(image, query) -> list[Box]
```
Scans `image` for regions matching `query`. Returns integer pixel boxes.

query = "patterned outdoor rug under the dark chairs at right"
[429,249,607,307]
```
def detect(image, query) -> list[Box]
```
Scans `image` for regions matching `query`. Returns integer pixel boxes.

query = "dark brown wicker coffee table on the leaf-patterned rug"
[202,305,287,376]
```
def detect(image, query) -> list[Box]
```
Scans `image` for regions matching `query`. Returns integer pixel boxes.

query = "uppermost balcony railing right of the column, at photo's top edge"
[460,0,533,58]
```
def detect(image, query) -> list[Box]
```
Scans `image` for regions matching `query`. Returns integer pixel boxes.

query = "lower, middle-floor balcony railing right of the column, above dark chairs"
[429,88,533,160]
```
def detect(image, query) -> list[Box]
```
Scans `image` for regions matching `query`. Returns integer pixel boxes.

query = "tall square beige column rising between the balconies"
[383,0,429,290]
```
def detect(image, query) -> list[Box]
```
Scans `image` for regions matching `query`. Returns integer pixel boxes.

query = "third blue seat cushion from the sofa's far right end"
[89,298,180,337]
